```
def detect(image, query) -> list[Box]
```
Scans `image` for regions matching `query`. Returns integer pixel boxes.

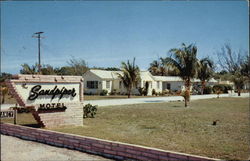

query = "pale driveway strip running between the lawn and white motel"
[84,93,249,106]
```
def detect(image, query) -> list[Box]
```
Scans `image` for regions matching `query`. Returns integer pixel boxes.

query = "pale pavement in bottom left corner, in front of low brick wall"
[1,135,108,161]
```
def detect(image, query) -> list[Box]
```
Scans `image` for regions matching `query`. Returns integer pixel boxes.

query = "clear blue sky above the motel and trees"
[0,0,249,74]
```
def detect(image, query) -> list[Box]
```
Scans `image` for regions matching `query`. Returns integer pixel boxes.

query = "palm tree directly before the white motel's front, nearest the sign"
[117,58,140,98]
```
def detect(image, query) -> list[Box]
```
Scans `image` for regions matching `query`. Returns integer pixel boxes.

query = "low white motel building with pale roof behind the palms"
[83,69,217,95]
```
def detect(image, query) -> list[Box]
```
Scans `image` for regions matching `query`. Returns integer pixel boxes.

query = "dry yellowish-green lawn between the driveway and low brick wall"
[1,98,250,160]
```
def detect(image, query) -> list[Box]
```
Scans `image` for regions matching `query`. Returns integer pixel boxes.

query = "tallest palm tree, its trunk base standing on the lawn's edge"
[164,43,199,107]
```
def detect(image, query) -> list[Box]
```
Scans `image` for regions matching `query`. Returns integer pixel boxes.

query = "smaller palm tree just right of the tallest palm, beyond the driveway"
[198,57,214,94]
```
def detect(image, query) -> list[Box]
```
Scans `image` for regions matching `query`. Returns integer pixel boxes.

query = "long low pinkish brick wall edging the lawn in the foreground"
[1,123,217,161]
